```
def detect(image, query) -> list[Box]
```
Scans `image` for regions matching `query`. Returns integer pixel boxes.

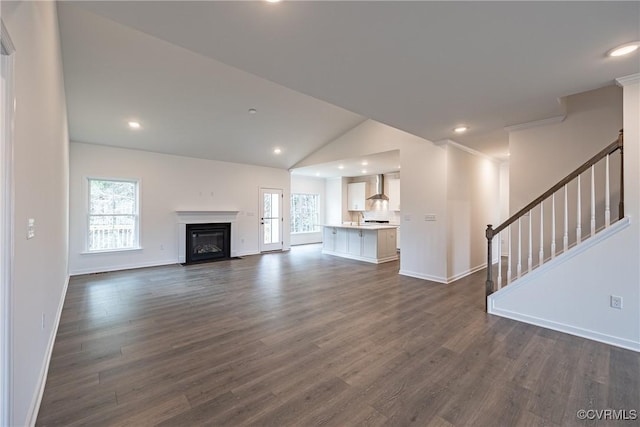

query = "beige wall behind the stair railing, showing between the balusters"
[501,86,622,264]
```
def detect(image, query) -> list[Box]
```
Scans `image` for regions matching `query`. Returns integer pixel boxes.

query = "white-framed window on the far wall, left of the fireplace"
[87,178,139,251]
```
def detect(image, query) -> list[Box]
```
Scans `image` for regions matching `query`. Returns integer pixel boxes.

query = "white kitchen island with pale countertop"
[322,224,398,264]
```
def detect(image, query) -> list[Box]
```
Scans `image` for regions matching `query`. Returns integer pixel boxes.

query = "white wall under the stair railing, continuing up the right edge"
[491,75,640,351]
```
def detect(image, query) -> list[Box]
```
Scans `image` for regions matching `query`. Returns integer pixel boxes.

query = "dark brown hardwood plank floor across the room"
[37,245,640,426]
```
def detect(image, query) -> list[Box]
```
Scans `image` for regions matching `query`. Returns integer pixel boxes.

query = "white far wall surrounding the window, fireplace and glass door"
[69,142,290,274]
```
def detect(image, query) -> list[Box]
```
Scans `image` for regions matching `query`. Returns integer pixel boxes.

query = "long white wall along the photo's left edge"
[0,1,69,425]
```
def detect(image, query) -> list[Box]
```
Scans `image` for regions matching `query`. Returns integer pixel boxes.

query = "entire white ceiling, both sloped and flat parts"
[59,1,640,176]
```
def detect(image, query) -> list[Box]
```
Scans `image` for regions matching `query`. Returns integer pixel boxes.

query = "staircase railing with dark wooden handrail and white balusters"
[485,131,624,308]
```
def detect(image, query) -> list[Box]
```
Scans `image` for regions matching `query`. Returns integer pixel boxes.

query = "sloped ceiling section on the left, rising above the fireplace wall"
[59,4,364,169]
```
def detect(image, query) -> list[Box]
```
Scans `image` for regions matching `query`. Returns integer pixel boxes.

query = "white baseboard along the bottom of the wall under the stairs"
[488,301,640,352]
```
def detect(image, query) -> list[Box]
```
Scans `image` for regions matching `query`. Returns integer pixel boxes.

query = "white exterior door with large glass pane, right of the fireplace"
[260,188,284,252]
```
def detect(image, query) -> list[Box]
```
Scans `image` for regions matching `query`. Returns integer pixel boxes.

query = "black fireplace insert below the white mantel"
[185,222,231,264]
